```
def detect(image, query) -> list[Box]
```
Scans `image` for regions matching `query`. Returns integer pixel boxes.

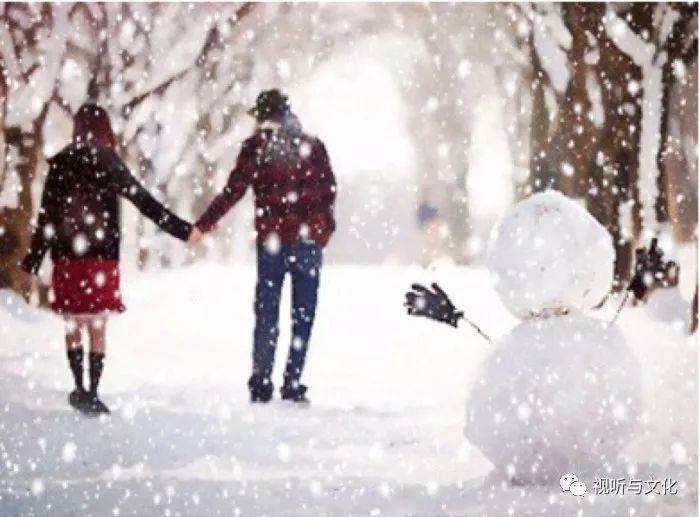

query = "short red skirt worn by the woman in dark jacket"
[51,258,125,314]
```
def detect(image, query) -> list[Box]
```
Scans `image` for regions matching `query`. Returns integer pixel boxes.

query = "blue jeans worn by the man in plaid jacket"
[253,242,323,387]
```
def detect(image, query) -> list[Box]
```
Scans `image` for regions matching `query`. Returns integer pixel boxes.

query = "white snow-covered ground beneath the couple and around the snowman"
[0,264,697,517]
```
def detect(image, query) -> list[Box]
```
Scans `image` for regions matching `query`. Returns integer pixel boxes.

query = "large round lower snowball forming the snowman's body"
[465,314,641,483]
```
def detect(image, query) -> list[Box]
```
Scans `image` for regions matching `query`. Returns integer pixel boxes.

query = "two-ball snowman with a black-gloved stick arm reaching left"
[405,191,642,484]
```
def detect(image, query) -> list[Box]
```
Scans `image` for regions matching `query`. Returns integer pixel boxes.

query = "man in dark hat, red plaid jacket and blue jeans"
[196,90,336,402]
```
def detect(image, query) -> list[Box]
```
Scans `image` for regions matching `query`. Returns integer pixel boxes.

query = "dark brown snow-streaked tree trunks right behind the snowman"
[505,3,697,285]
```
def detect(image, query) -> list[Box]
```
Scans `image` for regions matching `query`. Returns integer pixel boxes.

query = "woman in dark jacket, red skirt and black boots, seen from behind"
[22,104,192,413]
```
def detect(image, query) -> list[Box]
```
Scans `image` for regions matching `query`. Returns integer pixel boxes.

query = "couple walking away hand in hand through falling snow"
[22,90,336,414]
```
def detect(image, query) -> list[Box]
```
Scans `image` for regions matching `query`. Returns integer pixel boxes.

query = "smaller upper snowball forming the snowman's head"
[488,191,615,318]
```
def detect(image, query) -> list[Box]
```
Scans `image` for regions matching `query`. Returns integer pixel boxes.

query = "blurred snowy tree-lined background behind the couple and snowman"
[0,3,698,296]
